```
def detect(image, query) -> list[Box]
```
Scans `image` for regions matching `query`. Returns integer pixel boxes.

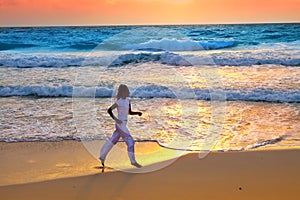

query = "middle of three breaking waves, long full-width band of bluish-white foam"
[0,50,300,68]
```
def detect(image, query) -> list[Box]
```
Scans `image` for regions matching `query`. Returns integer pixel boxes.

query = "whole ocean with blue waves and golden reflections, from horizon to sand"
[0,23,300,151]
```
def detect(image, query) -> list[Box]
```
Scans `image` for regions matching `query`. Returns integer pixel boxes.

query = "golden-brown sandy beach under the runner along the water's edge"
[0,141,300,200]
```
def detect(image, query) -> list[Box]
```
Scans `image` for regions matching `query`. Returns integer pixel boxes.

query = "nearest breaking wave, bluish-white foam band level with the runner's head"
[0,85,300,102]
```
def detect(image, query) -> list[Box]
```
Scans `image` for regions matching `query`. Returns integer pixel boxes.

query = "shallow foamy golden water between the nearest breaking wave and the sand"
[0,96,299,151]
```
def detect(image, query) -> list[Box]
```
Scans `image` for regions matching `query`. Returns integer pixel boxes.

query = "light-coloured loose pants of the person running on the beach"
[100,121,136,163]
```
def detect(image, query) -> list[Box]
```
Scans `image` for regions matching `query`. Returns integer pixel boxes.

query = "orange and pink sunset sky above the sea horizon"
[0,0,300,26]
